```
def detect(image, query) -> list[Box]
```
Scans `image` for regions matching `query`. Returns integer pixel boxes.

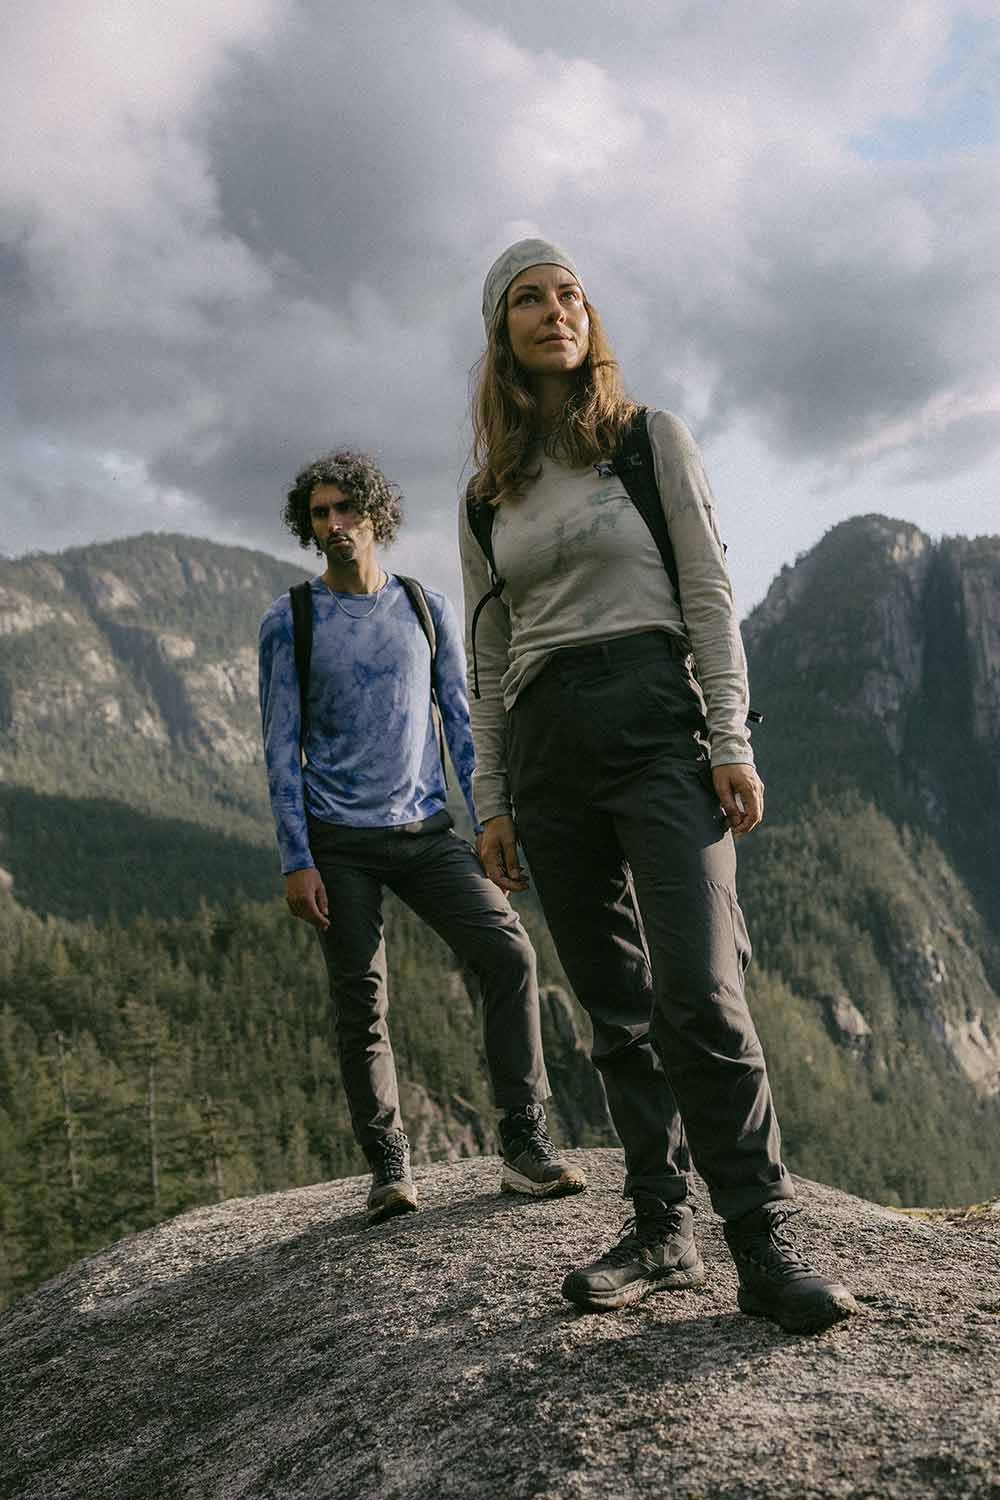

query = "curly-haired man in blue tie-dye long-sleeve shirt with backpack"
[259,449,586,1223]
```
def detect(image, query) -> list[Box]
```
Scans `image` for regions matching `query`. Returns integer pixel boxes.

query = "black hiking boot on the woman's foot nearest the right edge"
[724,1200,861,1334]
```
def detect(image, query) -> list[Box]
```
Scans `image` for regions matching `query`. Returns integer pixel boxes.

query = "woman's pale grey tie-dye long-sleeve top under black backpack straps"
[459,411,753,822]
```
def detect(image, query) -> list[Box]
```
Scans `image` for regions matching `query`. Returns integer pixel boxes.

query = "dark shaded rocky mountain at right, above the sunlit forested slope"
[744,516,1000,929]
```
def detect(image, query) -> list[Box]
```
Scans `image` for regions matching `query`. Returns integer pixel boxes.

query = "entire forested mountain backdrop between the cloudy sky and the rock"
[0,518,1000,1298]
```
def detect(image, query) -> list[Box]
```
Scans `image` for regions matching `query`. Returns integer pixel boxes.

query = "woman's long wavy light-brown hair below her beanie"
[472,299,636,506]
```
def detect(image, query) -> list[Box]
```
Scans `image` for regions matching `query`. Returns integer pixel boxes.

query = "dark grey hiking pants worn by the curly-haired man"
[309,819,549,1151]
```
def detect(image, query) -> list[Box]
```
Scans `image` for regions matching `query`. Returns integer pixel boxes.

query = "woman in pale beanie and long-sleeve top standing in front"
[460,240,856,1331]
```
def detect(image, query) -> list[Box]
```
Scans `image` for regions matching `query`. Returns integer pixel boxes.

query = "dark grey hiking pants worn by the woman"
[507,630,793,1218]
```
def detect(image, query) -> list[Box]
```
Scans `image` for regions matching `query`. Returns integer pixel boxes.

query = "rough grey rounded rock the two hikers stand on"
[0,1151,1000,1500]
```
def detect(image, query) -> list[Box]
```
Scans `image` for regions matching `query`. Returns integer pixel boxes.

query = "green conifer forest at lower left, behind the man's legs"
[0,894,610,1301]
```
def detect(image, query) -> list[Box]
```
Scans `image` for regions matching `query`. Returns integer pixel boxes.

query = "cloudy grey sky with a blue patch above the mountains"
[0,0,1000,608]
